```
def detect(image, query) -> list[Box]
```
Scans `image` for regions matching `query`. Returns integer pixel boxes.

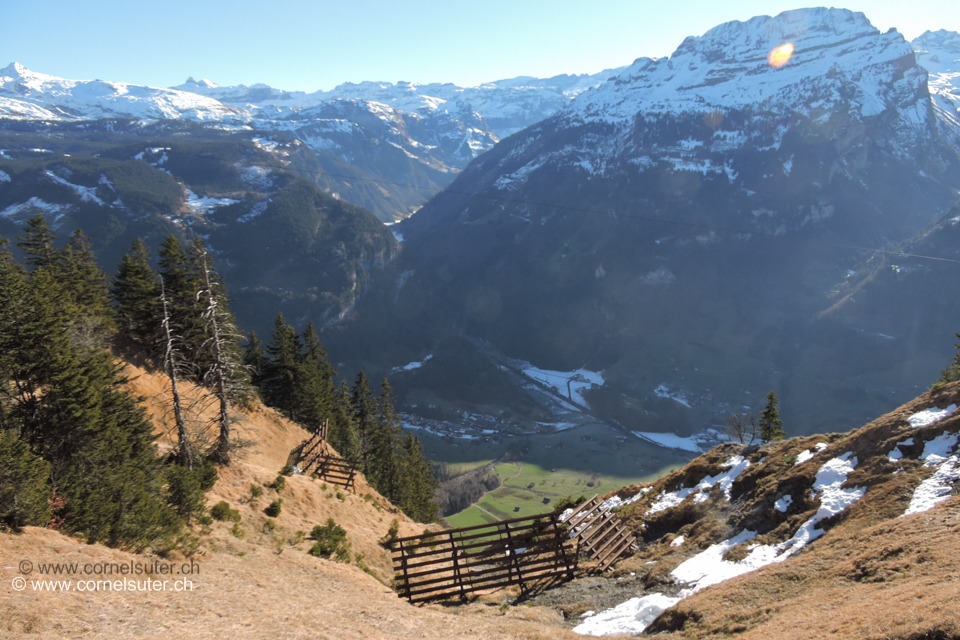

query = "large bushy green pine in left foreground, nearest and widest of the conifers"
[10,267,178,547]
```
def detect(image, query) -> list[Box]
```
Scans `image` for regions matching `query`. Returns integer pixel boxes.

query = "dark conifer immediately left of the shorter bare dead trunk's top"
[110,238,163,355]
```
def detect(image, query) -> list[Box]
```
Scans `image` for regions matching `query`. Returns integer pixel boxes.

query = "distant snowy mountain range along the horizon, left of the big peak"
[0,63,619,221]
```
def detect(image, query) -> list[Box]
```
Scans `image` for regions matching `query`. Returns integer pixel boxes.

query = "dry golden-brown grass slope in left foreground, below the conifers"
[0,365,575,640]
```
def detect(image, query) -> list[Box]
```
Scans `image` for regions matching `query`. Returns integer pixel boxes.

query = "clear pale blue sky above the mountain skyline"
[0,0,960,91]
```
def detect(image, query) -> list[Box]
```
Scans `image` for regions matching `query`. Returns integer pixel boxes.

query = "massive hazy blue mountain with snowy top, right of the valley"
[340,9,960,432]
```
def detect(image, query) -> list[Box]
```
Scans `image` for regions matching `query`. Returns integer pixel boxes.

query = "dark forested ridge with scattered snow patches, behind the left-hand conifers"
[0,136,399,335]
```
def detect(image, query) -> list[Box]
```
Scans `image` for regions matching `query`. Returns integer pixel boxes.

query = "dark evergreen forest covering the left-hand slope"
[0,215,437,549]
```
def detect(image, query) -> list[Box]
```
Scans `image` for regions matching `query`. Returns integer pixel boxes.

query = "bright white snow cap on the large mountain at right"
[566,8,926,126]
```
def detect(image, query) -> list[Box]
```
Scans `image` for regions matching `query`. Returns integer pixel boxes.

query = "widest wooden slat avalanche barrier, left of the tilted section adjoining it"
[390,513,577,603]
